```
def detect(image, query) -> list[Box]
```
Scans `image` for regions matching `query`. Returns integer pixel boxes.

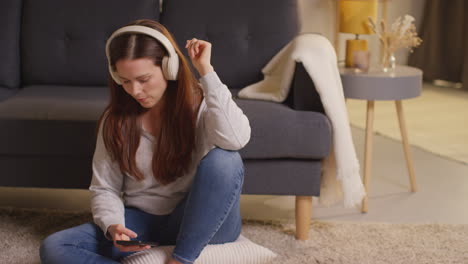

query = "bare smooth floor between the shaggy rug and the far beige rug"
[241,125,468,224]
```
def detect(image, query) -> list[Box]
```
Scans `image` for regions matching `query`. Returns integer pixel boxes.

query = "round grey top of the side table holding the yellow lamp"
[340,65,423,100]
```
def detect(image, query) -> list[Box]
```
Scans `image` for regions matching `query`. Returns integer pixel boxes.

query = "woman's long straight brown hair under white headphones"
[99,19,198,185]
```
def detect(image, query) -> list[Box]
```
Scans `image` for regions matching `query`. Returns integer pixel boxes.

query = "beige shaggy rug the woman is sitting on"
[0,208,468,264]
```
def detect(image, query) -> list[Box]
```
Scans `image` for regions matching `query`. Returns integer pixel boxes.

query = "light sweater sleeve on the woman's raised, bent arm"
[200,72,250,150]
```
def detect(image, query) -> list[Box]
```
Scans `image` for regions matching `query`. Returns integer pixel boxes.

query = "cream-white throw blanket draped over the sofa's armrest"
[238,34,365,207]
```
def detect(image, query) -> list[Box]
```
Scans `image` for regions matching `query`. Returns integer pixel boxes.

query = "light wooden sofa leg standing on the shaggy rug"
[296,196,312,240]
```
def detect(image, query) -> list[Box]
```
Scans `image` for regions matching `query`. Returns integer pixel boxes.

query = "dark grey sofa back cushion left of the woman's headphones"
[21,0,159,85]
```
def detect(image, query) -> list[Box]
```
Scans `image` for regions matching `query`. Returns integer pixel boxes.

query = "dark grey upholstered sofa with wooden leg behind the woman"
[0,0,331,239]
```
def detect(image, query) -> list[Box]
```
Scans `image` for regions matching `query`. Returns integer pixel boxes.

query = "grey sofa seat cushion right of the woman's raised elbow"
[235,96,331,159]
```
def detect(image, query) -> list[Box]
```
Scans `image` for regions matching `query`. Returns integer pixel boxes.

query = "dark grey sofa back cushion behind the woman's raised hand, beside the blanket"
[161,0,299,89]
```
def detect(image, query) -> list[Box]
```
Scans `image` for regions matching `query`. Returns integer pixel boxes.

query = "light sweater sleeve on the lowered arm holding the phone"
[89,121,125,239]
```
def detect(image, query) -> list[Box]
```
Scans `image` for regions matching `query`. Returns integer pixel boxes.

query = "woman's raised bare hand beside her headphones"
[185,38,214,76]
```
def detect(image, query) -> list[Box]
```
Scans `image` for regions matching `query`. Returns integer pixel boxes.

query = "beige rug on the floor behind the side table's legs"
[347,84,468,164]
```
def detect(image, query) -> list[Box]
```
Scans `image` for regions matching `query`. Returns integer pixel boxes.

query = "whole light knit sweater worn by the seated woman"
[89,72,250,233]
